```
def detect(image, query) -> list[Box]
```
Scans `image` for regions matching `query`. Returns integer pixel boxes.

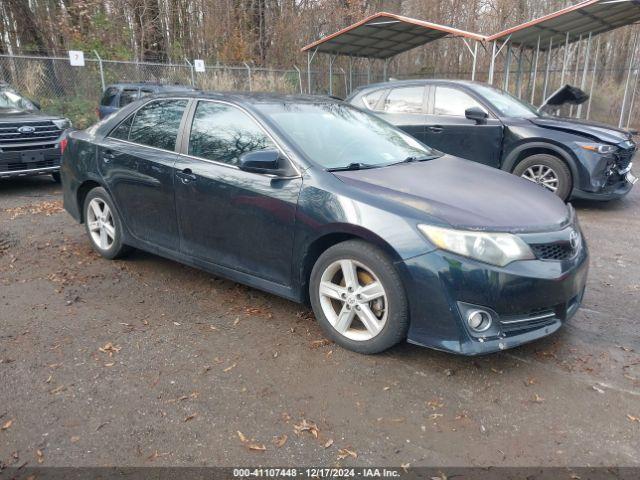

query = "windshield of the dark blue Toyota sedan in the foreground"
[256,103,441,169]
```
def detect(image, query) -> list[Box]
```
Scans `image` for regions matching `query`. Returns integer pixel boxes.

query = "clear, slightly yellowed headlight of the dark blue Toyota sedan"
[418,225,535,267]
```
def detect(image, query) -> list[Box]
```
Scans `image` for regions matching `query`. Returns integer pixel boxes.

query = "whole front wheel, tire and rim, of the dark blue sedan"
[309,240,409,354]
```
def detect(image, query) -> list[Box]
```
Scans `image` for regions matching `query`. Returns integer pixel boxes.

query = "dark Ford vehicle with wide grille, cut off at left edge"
[0,83,71,181]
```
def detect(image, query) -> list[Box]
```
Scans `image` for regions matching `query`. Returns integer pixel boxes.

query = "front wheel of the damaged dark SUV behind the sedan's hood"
[513,153,573,201]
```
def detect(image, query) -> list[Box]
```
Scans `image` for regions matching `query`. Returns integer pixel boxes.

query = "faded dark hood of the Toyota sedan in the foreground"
[334,155,570,233]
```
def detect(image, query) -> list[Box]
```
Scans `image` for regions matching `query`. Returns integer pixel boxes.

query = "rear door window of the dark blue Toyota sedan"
[129,100,188,150]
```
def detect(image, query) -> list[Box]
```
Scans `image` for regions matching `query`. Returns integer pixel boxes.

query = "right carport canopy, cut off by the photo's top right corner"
[487,0,640,50]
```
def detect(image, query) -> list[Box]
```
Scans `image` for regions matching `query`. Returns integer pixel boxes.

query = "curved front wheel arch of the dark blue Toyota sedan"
[299,224,401,303]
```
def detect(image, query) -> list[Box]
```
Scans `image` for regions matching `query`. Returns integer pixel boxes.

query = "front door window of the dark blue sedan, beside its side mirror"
[189,102,277,165]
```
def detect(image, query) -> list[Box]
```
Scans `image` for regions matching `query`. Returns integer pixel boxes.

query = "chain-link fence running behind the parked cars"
[0,55,640,128]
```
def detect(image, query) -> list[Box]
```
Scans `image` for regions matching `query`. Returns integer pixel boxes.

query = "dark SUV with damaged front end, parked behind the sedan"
[347,80,637,200]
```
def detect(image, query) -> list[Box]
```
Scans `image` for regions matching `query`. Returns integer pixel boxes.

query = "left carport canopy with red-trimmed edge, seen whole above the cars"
[302,12,486,59]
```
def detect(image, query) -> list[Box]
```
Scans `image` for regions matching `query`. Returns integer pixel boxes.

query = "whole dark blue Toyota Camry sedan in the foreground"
[62,92,588,355]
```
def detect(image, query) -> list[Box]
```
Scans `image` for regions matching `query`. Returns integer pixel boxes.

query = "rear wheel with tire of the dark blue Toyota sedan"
[84,187,131,260]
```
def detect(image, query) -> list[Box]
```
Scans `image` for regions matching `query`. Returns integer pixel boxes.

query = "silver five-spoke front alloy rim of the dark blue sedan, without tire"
[319,259,388,341]
